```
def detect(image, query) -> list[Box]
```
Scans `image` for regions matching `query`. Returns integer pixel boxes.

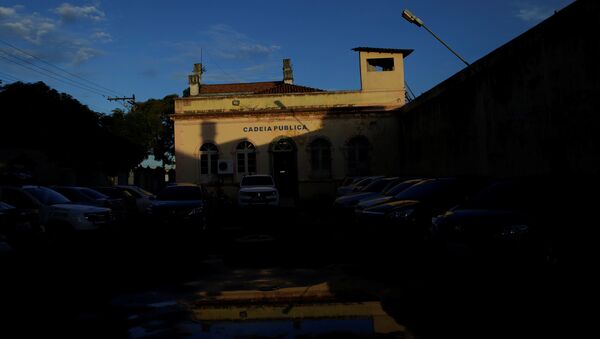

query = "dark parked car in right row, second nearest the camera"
[357,178,487,238]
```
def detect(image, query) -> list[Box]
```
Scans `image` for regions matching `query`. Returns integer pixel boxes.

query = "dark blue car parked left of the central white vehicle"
[146,184,210,231]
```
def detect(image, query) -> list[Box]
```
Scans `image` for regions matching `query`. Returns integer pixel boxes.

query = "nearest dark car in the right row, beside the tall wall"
[432,180,565,261]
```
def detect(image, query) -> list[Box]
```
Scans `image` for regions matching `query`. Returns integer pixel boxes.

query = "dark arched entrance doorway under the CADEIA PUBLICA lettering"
[271,137,298,197]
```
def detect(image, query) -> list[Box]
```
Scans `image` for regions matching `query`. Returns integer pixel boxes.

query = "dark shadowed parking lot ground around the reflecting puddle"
[0,206,576,338]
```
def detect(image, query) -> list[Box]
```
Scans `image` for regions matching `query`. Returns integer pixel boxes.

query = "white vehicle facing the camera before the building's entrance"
[238,175,279,206]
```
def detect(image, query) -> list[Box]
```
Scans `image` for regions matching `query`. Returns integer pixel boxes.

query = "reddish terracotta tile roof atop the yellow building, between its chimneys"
[200,81,323,95]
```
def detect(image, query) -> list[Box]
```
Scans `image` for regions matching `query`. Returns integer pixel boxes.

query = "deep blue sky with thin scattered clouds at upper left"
[0,0,573,112]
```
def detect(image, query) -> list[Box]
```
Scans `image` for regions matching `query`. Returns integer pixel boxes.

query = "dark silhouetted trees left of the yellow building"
[0,82,177,182]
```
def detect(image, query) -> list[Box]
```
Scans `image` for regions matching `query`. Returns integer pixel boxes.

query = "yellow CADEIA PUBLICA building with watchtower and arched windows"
[173,47,412,198]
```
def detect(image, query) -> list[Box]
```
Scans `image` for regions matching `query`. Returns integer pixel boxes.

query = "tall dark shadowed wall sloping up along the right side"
[399,0,600,176]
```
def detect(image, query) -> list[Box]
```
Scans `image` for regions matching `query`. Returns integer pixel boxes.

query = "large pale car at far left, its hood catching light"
[0,186,112,234]
